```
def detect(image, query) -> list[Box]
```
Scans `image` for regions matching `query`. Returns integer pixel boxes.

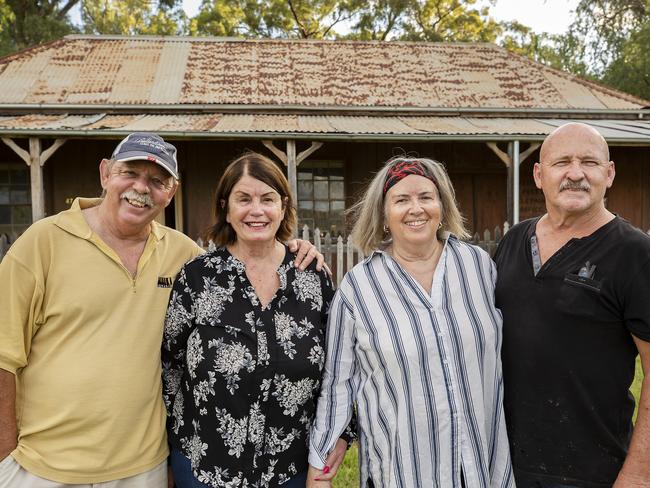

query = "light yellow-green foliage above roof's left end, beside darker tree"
[81,0,187,35]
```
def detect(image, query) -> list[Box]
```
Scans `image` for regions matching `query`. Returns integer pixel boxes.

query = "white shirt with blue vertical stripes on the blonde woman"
[309,236,514,488]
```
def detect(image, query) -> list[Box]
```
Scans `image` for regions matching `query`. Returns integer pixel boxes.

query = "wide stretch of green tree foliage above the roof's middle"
[190,0,499,41]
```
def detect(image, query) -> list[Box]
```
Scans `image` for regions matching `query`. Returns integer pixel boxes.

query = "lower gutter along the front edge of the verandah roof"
[0,129,650,147]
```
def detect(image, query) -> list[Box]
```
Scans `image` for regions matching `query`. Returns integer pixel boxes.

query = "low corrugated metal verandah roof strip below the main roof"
[0,113,650,146]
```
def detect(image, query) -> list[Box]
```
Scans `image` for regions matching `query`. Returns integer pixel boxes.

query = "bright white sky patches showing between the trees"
[183,0,578,34]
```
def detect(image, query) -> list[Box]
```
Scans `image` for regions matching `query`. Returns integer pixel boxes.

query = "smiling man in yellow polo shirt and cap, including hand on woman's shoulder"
[0,133,322,488]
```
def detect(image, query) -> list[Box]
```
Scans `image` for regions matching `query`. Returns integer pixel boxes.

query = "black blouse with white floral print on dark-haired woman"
[162,248,333,488]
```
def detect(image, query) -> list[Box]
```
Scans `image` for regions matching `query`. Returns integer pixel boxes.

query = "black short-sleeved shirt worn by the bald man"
[495,217,650,487]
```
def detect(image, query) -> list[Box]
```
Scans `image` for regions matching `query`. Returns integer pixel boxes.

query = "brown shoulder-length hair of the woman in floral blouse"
[207,152,297,246]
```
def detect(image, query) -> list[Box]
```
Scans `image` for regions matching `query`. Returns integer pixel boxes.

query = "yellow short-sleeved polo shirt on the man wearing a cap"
[0,199,201,484]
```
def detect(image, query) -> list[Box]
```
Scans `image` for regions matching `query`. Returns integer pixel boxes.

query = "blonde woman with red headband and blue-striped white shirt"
[308,157,514,488]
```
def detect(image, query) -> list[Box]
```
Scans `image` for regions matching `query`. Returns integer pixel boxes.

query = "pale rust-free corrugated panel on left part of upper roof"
[149,42,192,103]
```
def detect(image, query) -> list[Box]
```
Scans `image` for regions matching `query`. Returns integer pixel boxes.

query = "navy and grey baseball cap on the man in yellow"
[111,132,178,179]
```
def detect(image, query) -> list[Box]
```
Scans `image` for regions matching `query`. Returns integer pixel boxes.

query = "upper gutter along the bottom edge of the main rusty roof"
[0,103,650,119]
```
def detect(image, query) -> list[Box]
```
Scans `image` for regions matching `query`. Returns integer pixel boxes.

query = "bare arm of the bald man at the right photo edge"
[613,336,650,488]
